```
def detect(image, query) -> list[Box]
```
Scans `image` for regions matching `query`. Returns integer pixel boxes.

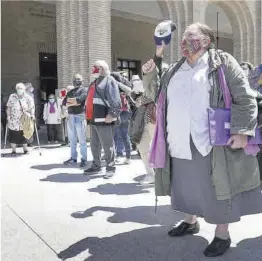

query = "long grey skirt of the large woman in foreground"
[171,142,262,224]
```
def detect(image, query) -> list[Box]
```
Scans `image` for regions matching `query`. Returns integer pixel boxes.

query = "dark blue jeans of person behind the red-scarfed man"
[114,121,131,159]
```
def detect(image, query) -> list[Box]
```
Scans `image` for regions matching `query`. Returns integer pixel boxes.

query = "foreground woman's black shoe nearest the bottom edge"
[204,237,231,257]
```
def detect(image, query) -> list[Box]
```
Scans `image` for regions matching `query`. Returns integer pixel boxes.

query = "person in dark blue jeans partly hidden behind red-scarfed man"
[111,72,132,164]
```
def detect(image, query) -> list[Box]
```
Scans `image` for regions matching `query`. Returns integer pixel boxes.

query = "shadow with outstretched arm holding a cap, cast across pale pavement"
[71,205,184,225]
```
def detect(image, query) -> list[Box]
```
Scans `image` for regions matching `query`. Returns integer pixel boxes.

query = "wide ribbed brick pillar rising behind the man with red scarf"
[56,0,111,140]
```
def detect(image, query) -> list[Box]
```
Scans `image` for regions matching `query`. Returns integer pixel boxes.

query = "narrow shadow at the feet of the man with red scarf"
[40,173,103,183]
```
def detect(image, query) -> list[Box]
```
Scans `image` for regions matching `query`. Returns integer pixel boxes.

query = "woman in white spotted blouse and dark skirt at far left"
[6,83,35,155]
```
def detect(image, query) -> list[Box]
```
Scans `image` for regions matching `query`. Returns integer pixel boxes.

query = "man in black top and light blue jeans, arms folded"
[63,74,87,168]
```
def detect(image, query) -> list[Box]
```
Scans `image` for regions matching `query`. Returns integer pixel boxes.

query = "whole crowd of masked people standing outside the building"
[2,23,262,257]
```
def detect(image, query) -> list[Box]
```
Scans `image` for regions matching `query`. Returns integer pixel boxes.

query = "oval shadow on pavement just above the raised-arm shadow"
[89,183,153,195]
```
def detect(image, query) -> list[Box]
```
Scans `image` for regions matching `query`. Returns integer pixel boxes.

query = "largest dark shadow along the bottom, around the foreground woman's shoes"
[58,226,262,261]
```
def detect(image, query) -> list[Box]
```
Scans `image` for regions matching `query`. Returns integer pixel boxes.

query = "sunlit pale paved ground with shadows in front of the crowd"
[1,137,262,261]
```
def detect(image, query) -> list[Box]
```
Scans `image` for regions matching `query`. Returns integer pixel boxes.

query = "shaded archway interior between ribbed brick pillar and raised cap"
[111,0,171,78]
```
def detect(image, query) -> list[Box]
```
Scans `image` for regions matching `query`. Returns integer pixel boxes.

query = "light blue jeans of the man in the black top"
[67,114,87,161]
